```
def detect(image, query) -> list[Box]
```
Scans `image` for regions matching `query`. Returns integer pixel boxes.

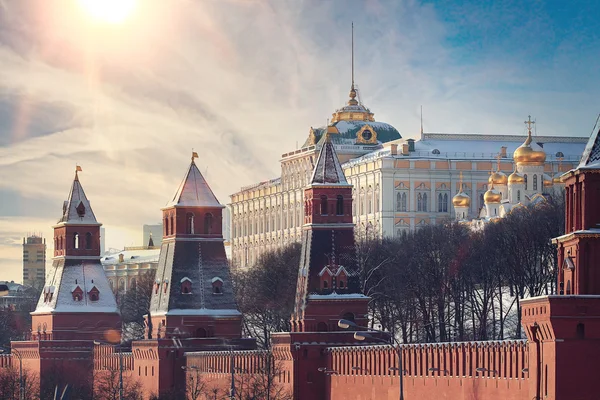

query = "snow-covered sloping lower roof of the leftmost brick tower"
[33,260,119,314]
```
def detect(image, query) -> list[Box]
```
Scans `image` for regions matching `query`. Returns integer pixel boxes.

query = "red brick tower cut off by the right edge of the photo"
[522,124,600,400]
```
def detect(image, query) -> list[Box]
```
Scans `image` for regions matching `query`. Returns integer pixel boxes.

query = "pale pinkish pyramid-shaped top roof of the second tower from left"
[166,159,223,208]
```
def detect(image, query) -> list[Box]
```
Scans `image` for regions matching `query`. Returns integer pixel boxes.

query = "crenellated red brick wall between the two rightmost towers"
[327,341,529,400]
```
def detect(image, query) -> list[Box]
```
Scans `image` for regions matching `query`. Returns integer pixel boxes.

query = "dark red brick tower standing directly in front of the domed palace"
[271,137,369,400]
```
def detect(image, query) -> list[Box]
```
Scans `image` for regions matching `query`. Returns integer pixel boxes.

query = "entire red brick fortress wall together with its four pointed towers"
[0,101,600,400]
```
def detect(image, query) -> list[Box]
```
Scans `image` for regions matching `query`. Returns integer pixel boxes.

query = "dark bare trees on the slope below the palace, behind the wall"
[235,196,564,347]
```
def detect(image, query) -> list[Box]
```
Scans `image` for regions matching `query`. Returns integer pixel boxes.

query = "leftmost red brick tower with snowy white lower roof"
[31,167,121,340]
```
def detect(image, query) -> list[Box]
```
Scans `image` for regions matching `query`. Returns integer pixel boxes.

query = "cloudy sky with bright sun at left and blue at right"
[0,0,600,281]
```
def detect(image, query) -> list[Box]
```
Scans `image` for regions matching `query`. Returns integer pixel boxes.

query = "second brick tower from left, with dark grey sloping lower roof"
[147,153,242,339]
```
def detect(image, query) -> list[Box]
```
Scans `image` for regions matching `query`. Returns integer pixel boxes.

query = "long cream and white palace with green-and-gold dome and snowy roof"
[228,87,587,266]
